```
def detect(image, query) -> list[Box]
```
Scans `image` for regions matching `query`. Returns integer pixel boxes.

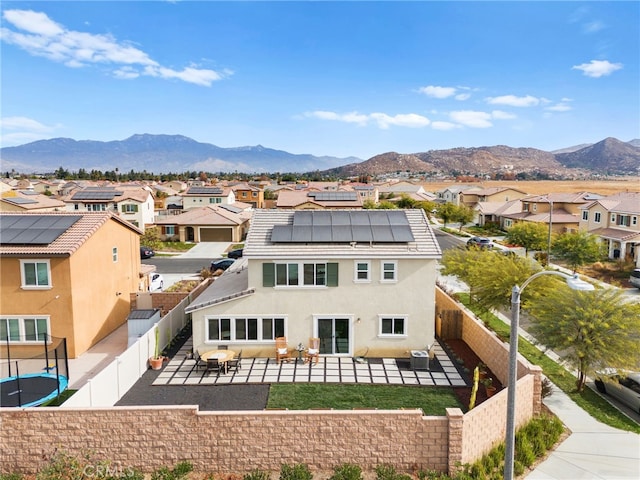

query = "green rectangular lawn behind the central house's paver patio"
[267,383,463,415]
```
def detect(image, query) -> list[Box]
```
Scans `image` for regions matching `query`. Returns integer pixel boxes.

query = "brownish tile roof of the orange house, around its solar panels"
[0,212,142,257]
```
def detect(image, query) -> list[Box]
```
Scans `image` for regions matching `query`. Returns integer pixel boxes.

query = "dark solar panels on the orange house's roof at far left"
[0,215,82,245]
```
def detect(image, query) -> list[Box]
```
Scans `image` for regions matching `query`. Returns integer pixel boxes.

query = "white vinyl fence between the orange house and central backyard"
[61,294,192,408]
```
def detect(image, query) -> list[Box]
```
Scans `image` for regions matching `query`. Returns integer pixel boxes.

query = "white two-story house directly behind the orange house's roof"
[63,185,154,232]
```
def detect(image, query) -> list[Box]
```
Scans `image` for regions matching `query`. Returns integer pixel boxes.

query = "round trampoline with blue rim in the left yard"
[0,373,68,407]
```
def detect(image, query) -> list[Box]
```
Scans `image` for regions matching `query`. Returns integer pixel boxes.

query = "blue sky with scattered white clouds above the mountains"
[0,1,640,159]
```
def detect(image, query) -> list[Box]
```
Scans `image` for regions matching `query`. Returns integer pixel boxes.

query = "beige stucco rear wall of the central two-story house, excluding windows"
[192,259,436,357]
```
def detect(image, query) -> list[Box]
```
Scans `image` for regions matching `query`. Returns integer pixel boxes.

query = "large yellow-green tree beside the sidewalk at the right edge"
[526,286,640,392]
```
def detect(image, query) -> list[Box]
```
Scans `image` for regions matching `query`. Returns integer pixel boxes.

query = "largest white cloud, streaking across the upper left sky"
[0,10,231,87]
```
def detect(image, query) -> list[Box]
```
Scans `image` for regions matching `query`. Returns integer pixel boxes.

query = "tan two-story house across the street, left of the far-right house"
[502,192,601,233]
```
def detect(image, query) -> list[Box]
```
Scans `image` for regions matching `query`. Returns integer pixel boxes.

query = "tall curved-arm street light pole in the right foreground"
[504,270,594,480]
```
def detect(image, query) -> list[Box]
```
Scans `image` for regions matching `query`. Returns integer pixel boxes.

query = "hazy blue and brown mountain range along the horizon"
[0,134,640,177]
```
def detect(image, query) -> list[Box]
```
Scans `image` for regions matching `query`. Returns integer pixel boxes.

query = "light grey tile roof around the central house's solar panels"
[243,209,441,259]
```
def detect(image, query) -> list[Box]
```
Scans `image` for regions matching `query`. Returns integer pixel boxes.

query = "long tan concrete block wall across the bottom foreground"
[0,406,452,474]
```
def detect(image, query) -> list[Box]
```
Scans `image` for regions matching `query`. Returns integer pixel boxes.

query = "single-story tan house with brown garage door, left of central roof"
[156,203,251,242]
